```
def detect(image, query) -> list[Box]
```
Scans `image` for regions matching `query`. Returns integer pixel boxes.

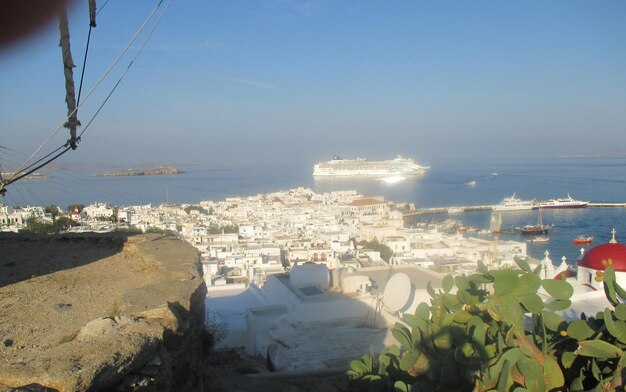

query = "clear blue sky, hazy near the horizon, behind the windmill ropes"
[0,0,626,165]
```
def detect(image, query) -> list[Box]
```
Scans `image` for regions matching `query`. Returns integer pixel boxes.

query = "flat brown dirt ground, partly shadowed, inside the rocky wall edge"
[0,234,163,361]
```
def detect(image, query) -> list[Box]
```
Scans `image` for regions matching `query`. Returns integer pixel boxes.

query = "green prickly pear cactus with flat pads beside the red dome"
[348,260,626,392]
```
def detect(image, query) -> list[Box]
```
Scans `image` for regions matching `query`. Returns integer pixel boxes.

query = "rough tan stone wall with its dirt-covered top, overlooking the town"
[0,234,206,391]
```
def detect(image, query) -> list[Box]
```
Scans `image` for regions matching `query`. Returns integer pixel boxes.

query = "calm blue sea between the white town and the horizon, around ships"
[0,157,626,264]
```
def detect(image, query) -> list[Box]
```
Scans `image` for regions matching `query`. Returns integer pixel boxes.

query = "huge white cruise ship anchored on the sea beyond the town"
[313,155,430,177]
